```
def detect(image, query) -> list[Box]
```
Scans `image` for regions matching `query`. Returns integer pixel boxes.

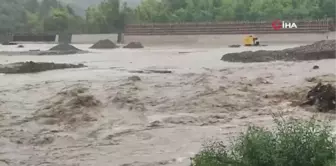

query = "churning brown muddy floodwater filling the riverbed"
[0,44,336,166]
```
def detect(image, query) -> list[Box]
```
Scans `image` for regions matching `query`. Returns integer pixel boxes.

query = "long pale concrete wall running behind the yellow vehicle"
[124,32,336,47]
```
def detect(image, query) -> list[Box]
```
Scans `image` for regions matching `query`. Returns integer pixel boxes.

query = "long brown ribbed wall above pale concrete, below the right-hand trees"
[125,20,332,36]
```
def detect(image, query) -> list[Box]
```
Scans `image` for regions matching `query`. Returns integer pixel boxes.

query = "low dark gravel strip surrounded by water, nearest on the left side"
[0,61,86,74]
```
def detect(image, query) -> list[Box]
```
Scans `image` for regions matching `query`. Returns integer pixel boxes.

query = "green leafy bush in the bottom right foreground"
[192,118,336,166]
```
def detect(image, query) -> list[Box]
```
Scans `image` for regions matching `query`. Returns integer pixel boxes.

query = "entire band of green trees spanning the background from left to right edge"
[0,0,336,33]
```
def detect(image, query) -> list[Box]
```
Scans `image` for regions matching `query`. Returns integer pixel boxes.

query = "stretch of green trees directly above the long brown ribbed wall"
[136,0,336,22]
